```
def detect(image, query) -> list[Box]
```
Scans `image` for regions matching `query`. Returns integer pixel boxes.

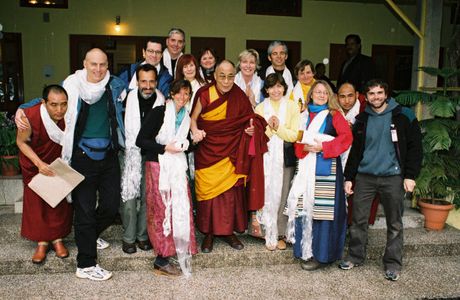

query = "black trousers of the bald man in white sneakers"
[72,149,120,268]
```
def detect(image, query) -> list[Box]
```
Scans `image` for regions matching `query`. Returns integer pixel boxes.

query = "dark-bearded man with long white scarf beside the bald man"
[120,64,165,254]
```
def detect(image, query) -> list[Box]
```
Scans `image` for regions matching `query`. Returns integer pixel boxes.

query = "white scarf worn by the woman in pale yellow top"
[257,97,289,248]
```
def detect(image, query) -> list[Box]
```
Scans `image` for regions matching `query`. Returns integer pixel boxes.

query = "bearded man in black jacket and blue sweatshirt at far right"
[339,79,423,281]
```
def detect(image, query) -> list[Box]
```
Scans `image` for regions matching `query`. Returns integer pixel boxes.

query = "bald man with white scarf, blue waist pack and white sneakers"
[62,48,126,281]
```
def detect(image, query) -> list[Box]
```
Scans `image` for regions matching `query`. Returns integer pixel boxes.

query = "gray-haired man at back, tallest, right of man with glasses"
[163,28,185,78]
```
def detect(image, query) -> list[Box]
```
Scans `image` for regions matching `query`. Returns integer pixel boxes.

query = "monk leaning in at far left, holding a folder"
[16,85,73,264]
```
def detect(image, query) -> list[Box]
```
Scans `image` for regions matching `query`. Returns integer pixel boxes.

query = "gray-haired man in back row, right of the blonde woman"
[265,41,294,95]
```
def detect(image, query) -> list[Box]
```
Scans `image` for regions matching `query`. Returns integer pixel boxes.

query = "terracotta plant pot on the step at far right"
[418,199,454,230]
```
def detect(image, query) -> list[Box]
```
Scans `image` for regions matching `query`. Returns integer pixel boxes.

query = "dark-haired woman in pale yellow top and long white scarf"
[251,73,300,251]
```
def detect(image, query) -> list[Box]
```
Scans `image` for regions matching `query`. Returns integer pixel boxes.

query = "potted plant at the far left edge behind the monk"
[0,112,19,176]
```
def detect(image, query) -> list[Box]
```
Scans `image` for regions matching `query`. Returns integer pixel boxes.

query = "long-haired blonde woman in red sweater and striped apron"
[287,80,353,271]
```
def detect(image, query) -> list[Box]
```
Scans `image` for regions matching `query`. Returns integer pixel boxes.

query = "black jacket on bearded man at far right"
[344,105,423,181]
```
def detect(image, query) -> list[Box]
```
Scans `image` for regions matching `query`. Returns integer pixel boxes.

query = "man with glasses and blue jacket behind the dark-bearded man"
[119,38,173,98]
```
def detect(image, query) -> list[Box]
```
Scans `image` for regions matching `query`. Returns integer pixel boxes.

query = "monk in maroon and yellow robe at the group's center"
[191,60,268,252]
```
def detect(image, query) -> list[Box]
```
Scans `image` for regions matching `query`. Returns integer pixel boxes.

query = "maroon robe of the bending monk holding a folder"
[19,104,73,242]
